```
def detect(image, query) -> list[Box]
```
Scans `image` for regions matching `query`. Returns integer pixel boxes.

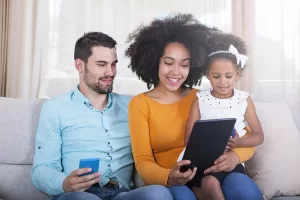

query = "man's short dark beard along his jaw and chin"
[84,65,114,94]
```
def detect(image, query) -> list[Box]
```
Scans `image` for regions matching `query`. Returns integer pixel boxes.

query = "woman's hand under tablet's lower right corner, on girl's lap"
[204,151,239,174]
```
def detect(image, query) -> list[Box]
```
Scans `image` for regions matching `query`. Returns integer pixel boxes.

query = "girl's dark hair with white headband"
[206,31,247,72]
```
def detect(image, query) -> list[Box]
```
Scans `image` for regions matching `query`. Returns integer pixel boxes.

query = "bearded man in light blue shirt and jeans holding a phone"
[32,32,173,200]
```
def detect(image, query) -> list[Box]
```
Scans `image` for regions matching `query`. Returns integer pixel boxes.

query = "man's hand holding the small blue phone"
[63,168,101,192]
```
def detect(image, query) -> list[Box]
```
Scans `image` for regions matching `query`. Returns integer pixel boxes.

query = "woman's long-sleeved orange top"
[128,89,254,185]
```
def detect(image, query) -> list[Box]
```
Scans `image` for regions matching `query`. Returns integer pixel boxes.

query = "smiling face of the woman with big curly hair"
[158,42,191,91]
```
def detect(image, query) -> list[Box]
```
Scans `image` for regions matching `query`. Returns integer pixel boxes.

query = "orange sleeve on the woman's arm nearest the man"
[128,95,171,185]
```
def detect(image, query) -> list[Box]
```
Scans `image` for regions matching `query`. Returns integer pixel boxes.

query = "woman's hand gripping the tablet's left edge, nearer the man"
[168,160,197,186]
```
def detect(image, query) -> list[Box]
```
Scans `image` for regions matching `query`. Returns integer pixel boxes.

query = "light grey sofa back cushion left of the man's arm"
[0,98,45,164]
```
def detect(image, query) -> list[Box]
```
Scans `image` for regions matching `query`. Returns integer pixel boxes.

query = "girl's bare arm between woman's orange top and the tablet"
[184,98,201,146]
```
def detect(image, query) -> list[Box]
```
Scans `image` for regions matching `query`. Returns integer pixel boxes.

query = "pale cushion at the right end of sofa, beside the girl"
[246,103,300,199]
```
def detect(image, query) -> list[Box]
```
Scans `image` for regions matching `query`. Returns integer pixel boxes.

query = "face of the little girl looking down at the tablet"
[207,58,240,99]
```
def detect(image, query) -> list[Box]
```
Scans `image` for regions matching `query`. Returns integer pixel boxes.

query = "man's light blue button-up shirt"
[32,88,133,195]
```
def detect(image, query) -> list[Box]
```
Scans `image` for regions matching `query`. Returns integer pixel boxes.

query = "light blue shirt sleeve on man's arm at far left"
[31,102,67,196]
